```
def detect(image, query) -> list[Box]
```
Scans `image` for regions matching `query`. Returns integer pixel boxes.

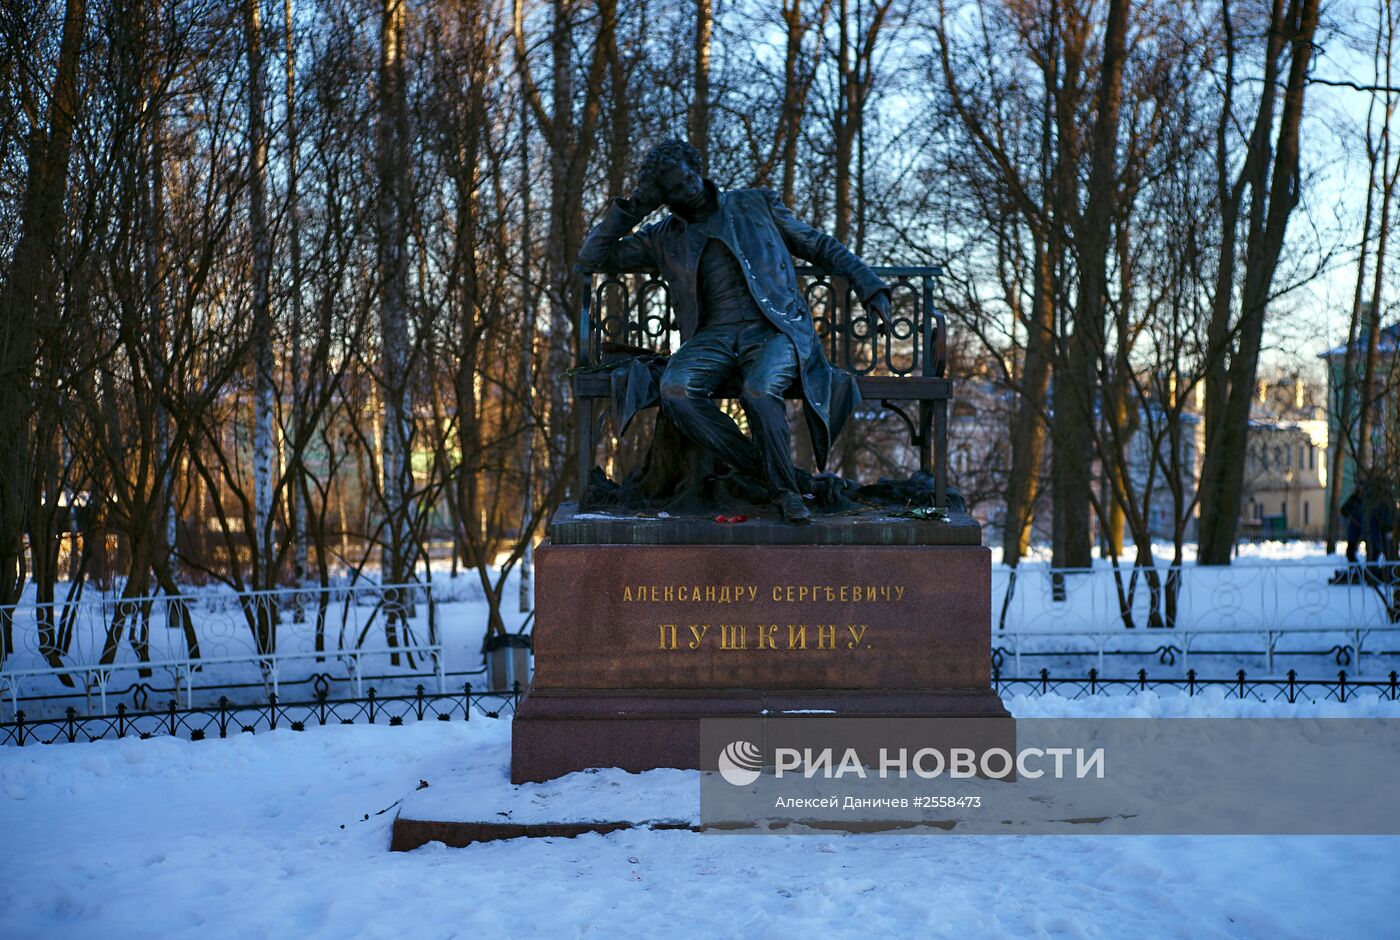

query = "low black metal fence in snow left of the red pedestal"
[0,682,521,747]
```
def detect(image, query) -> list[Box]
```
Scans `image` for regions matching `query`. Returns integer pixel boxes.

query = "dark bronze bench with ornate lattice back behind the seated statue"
[574,268,952,509]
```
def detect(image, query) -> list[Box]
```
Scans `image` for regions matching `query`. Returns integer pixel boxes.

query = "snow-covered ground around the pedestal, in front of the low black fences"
[0,693,1400,940]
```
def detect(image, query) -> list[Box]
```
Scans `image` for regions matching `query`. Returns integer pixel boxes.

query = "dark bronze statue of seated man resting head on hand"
[578,140,890,524]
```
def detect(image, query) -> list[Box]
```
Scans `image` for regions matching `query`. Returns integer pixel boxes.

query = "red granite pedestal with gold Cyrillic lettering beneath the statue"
[511,530,1008,783]
